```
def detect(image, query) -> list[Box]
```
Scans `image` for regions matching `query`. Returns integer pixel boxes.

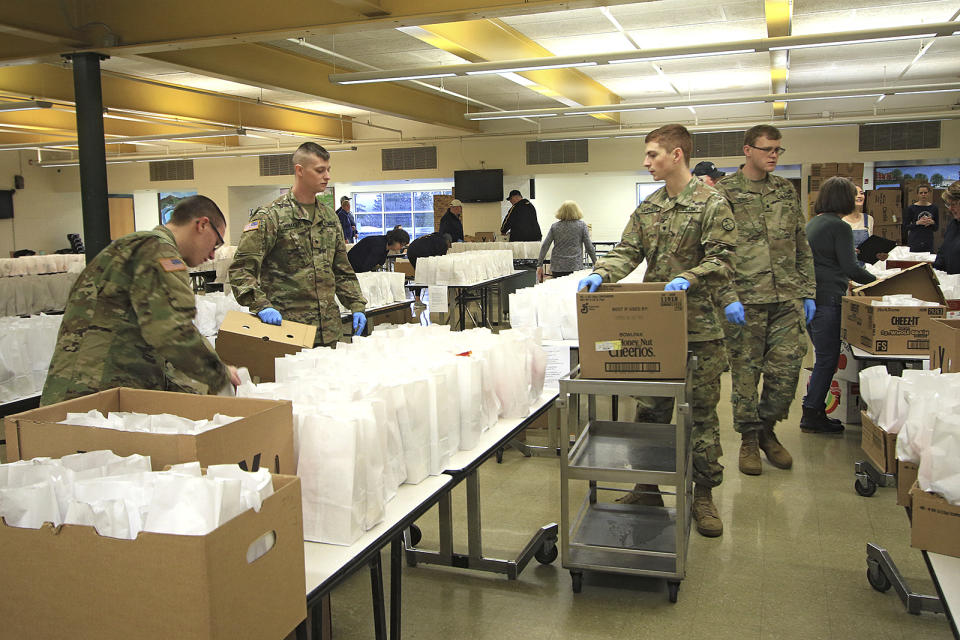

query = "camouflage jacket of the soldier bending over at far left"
[41,226,229,405]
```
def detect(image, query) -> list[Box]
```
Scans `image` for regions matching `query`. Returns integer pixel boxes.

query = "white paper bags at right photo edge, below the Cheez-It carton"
[860,366,960,505]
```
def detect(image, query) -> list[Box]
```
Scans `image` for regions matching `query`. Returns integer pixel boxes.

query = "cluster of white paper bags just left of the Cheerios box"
[510,269,590,340]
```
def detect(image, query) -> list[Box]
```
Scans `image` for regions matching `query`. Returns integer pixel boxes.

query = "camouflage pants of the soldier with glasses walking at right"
[727,300,807,433]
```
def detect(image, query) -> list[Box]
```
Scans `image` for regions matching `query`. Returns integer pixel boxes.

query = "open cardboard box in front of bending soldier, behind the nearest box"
[4,387,297,475]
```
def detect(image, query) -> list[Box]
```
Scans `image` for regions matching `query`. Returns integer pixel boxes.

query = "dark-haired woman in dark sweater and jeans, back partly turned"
[800,178,876,433]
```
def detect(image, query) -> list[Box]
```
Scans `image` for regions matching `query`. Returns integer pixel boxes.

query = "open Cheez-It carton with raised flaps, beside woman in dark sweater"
[840,264,946,357]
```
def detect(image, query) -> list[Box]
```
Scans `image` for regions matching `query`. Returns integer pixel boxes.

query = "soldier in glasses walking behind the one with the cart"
[716,125,816,475]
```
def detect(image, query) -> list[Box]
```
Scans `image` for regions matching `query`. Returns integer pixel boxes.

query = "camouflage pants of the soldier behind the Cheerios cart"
[636,340,727,487]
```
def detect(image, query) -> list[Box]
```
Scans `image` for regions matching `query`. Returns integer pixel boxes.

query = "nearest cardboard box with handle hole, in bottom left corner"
[0,476,306,640]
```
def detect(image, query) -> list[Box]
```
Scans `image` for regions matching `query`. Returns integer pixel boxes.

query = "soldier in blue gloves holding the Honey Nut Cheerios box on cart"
[580,125,742,537]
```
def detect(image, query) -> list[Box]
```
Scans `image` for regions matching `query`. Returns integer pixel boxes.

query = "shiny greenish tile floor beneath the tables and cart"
[0,364,950,640]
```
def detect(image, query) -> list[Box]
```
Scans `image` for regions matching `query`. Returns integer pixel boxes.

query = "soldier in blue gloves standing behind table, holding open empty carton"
[230,142,367,346]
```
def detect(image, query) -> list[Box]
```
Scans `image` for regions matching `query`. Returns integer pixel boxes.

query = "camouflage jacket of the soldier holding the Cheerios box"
[593,177,737,342]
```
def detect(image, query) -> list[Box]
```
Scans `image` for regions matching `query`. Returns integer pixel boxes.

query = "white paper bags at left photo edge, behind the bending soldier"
[0,315,63,403]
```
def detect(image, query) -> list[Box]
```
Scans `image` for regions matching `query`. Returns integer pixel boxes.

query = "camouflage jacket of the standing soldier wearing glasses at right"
[716,171,816,304]
